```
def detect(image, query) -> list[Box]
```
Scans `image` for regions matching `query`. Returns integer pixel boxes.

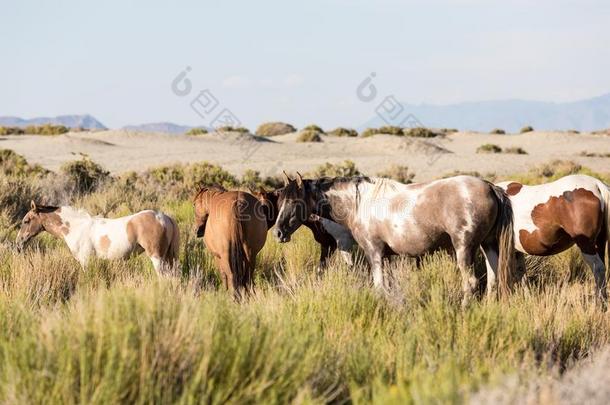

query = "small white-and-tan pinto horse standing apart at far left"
[16,201,180,274]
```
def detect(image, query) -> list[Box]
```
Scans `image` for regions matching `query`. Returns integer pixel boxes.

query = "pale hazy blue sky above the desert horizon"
[0,0,610,128]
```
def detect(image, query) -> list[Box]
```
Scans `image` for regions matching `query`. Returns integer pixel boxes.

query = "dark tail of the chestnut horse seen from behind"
[229,199,250,297]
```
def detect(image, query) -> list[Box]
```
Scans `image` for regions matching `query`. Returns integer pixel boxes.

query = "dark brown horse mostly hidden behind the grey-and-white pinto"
[250,188,354,273]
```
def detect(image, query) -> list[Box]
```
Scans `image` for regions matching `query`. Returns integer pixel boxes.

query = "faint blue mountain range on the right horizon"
[361,93,610,132]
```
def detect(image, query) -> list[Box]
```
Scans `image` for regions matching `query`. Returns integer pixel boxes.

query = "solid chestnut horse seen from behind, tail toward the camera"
[193,185,267,298]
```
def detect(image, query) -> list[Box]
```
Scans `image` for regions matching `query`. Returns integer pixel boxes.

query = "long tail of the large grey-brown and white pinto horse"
[490,183,517,296]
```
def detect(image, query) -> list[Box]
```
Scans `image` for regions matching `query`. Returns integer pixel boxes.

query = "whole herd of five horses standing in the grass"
[16,173,610,305]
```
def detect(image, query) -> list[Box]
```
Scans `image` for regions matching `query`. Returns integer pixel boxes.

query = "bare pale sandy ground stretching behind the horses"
[0,130,610,180]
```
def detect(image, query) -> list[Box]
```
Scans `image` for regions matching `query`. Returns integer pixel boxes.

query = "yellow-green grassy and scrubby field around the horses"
[0,150,610,404]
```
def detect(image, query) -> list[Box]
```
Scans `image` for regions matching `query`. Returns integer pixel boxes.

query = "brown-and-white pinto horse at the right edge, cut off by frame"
[497,174,610,304]
